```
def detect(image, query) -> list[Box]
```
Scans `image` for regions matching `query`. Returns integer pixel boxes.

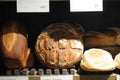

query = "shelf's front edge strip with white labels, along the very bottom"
[0,74,119,80]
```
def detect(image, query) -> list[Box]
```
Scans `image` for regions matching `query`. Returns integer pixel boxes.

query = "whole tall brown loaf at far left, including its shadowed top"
[0,22,33,69]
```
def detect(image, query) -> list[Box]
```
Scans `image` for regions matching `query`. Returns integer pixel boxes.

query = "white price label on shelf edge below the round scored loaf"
[41,75,73,80]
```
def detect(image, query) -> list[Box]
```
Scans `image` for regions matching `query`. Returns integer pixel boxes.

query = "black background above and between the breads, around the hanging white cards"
[0,0,120,72]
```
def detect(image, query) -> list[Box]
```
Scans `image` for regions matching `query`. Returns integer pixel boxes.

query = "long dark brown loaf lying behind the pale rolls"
[84,27,120,48]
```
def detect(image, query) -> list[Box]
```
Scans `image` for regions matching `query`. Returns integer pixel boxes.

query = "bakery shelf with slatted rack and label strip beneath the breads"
[0,68,120,80]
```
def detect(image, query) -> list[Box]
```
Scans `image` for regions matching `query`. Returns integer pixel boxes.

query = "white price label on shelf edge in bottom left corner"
[0,76,28,80]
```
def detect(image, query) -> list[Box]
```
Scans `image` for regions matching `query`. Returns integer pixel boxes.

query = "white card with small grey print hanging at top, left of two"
[17,0,49,12]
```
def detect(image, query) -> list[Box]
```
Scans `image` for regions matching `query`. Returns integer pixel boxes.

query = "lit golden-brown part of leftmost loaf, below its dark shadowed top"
[1,33,30,69]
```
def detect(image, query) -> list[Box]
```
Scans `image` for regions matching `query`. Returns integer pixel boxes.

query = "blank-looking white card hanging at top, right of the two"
[70,0,103,12]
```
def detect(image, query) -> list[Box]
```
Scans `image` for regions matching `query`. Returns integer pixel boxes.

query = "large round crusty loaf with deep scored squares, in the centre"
[35,23,84,68]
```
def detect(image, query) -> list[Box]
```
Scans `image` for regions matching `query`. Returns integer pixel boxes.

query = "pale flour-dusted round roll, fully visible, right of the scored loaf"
[80,48,116,71]
